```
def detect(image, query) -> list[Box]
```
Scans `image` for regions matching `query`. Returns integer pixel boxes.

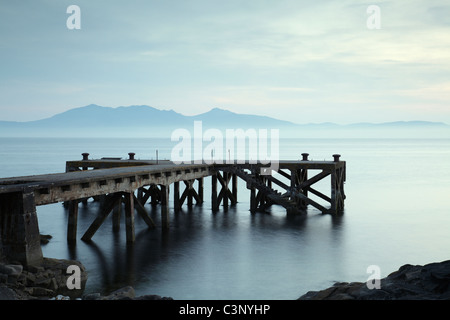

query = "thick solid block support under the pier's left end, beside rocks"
[0,189,43,266]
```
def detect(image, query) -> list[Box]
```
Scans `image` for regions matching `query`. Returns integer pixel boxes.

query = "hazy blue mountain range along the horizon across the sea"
[0,104,450,138]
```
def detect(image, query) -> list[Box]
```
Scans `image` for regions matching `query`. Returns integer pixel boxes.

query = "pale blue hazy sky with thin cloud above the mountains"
[0,0,450,124]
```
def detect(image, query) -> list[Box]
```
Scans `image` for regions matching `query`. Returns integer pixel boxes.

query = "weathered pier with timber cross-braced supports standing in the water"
[0,153,345,265]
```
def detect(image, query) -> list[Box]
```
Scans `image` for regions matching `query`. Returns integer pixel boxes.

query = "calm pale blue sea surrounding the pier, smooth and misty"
[0,138,450,300]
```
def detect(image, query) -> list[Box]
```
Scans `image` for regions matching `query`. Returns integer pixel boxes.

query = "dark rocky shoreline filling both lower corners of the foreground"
[0,250,450,300]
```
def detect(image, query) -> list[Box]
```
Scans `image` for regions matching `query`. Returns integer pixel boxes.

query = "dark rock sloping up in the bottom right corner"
[299,260,450,300]
